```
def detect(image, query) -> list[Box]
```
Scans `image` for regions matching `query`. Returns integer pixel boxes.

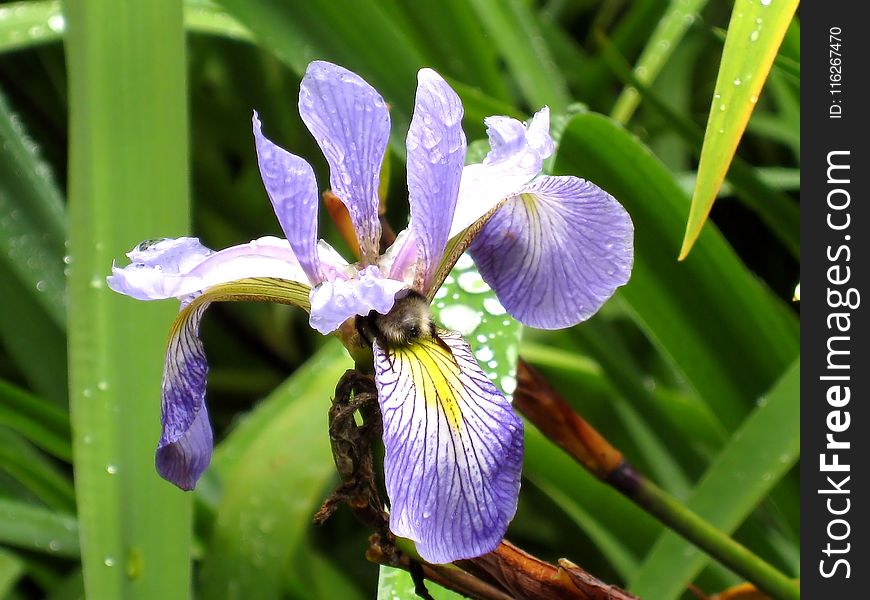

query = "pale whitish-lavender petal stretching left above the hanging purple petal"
[106,236,307,300]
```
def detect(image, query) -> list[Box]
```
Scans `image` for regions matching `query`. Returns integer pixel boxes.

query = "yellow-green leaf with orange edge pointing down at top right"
[680,0,798,255]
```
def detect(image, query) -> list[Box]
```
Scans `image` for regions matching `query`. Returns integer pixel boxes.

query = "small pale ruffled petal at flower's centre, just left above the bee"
[309,265,408,335]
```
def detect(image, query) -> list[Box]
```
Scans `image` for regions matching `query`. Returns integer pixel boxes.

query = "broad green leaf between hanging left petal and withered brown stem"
[200,341,351,599]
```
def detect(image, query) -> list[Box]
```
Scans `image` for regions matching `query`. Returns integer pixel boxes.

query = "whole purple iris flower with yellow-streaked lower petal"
[108,62,633,563]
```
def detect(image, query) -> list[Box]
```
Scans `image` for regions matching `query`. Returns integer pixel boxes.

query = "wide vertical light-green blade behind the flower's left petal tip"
[65,0,191,600]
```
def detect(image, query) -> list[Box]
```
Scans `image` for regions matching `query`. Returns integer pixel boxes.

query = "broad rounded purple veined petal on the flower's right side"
[471,177,634,329]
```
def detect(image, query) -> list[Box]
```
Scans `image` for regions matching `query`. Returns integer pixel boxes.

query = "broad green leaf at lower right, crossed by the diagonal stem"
[631,361,800,600]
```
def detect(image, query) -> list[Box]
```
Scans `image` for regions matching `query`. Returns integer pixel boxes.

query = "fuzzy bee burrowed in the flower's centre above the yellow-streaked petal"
[357,291,438,349]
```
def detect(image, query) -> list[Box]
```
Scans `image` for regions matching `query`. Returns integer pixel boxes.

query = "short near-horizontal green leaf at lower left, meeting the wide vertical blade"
[0,498,79,558]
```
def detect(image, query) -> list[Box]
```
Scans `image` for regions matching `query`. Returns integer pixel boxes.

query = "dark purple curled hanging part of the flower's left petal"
[156,302,213,490]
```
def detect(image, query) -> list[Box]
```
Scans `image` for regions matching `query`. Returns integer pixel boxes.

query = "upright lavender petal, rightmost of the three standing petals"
[406,69,465,290]
